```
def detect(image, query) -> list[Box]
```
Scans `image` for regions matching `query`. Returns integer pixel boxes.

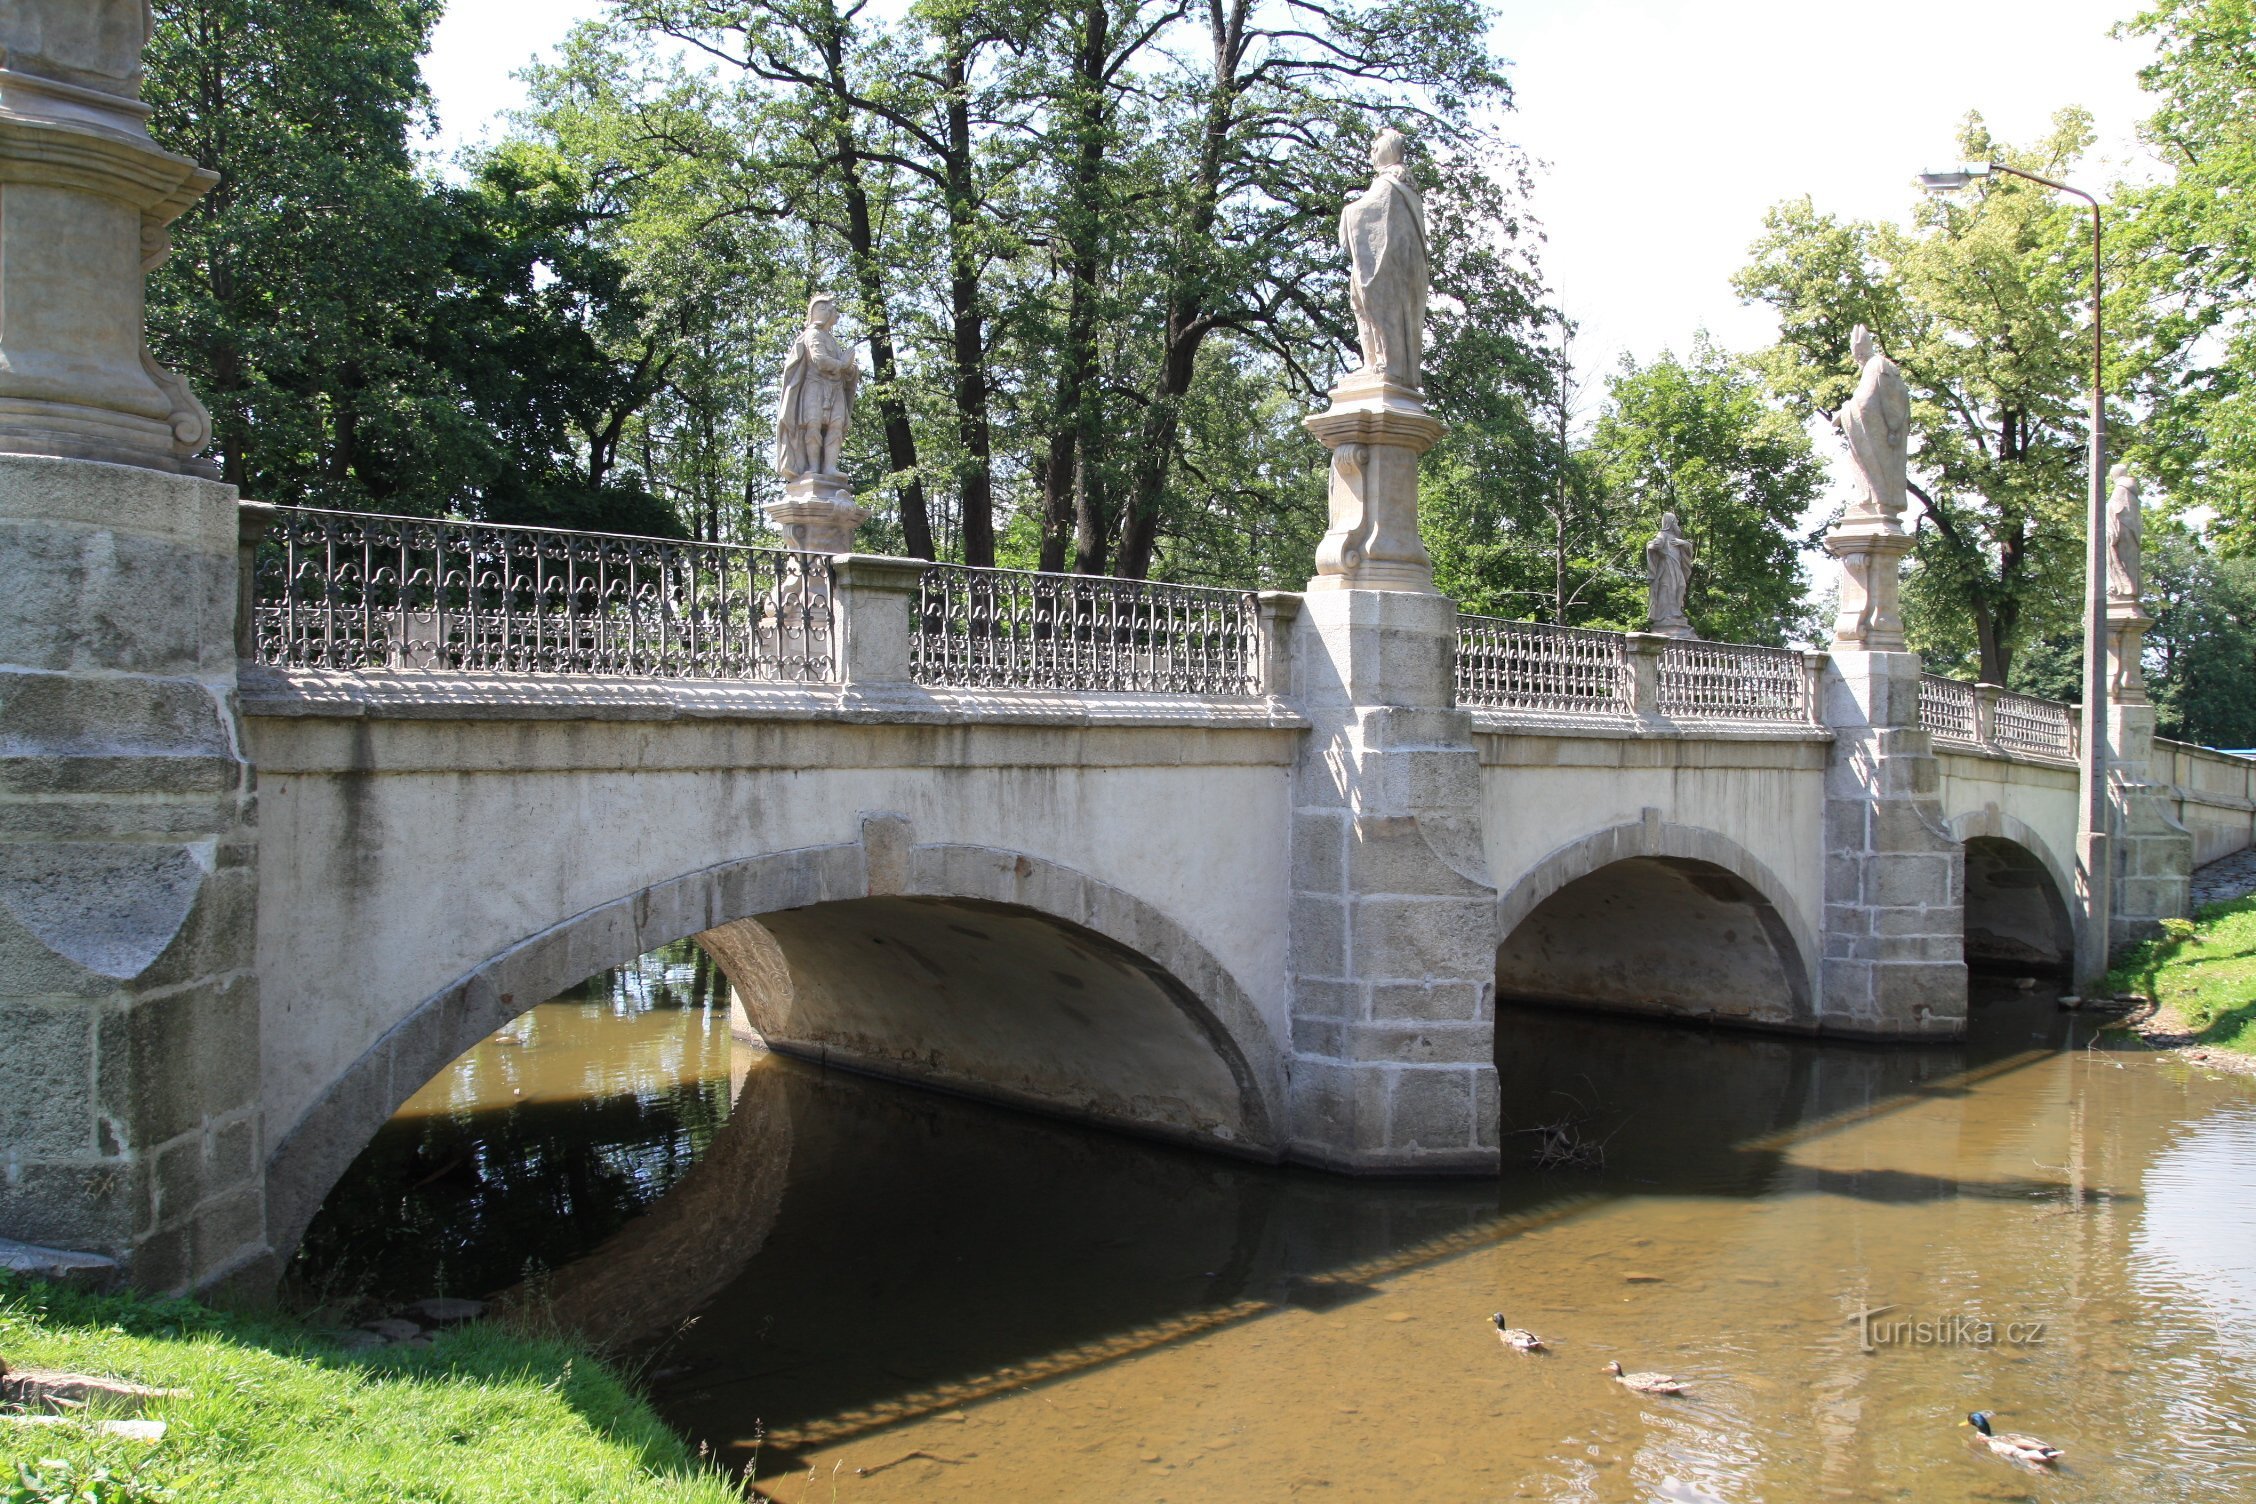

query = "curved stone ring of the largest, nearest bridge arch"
[266,816,1286,1258]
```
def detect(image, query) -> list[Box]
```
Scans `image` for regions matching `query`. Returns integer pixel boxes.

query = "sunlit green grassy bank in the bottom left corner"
[0,1276,744,1504]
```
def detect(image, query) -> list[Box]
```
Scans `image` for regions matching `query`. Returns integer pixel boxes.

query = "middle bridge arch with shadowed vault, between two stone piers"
[1496,809,1821,1028]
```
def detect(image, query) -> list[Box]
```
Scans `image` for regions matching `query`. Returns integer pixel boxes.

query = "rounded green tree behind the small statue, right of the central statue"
[1588,334,1825,647]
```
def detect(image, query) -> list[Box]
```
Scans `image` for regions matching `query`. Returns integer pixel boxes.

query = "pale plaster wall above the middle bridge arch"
[1478,731,1827,965]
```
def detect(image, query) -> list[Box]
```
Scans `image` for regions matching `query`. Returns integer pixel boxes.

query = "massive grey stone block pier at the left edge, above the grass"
[0,453,271,1290]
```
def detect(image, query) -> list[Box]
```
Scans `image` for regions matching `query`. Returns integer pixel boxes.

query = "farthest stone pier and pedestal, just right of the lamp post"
[2107,600,2193,952]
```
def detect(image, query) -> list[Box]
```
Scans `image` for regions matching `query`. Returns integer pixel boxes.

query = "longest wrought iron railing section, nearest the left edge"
[250,507,837,683]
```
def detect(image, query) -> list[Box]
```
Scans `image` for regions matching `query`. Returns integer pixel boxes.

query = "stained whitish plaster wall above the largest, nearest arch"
[250,701,1299,1141]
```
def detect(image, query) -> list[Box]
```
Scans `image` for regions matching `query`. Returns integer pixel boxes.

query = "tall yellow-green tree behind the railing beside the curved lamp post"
[1735,110,2111,683]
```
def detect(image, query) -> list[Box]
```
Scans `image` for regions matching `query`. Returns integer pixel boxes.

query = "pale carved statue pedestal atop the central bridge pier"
[1302,370,1444,593]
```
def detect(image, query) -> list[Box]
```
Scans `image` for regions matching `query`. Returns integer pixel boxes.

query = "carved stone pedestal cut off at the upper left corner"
[0,10,219,476]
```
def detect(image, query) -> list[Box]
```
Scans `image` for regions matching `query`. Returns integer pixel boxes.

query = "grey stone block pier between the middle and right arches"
[1818,640,1967,1035]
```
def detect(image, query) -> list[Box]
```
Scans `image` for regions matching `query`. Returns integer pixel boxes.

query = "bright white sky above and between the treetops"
[424,0,2150,374]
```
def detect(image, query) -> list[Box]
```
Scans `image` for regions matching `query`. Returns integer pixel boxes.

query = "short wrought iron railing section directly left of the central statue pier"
[909,564,1261,697]
